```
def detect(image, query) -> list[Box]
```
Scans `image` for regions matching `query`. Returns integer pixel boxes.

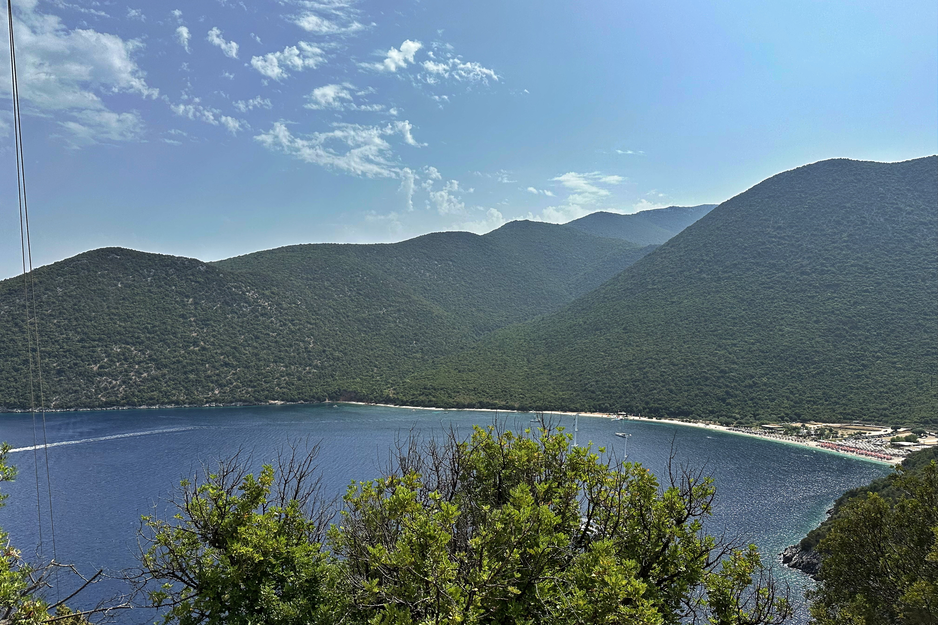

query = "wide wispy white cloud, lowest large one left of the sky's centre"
[254,121,419,178]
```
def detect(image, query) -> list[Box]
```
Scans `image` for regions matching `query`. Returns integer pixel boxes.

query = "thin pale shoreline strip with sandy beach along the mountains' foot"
[0,400,902,467]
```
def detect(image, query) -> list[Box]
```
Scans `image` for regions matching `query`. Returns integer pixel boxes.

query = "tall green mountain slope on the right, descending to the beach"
[398,157,938,423]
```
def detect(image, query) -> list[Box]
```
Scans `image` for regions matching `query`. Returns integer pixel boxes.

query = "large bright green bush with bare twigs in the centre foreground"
[136,425,791,625]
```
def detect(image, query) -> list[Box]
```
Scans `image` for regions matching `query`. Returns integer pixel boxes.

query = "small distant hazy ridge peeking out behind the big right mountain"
[566,204,716,245]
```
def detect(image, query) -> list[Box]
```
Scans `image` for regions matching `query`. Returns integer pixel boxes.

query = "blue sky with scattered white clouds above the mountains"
[0,0,938,278]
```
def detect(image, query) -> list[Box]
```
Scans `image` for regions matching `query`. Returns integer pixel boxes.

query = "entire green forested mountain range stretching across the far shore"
[0,157,938,423]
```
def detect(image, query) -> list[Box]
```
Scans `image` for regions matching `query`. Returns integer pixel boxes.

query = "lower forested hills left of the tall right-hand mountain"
[0,222,648,408]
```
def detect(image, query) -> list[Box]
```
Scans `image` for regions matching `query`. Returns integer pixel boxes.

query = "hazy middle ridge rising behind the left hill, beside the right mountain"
[215,222,649,336]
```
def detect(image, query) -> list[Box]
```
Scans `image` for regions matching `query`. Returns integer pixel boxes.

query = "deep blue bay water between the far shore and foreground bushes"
[0,404,890,623]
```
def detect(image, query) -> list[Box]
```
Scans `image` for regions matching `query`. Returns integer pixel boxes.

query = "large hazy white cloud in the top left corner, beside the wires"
[0,2,158,146]
